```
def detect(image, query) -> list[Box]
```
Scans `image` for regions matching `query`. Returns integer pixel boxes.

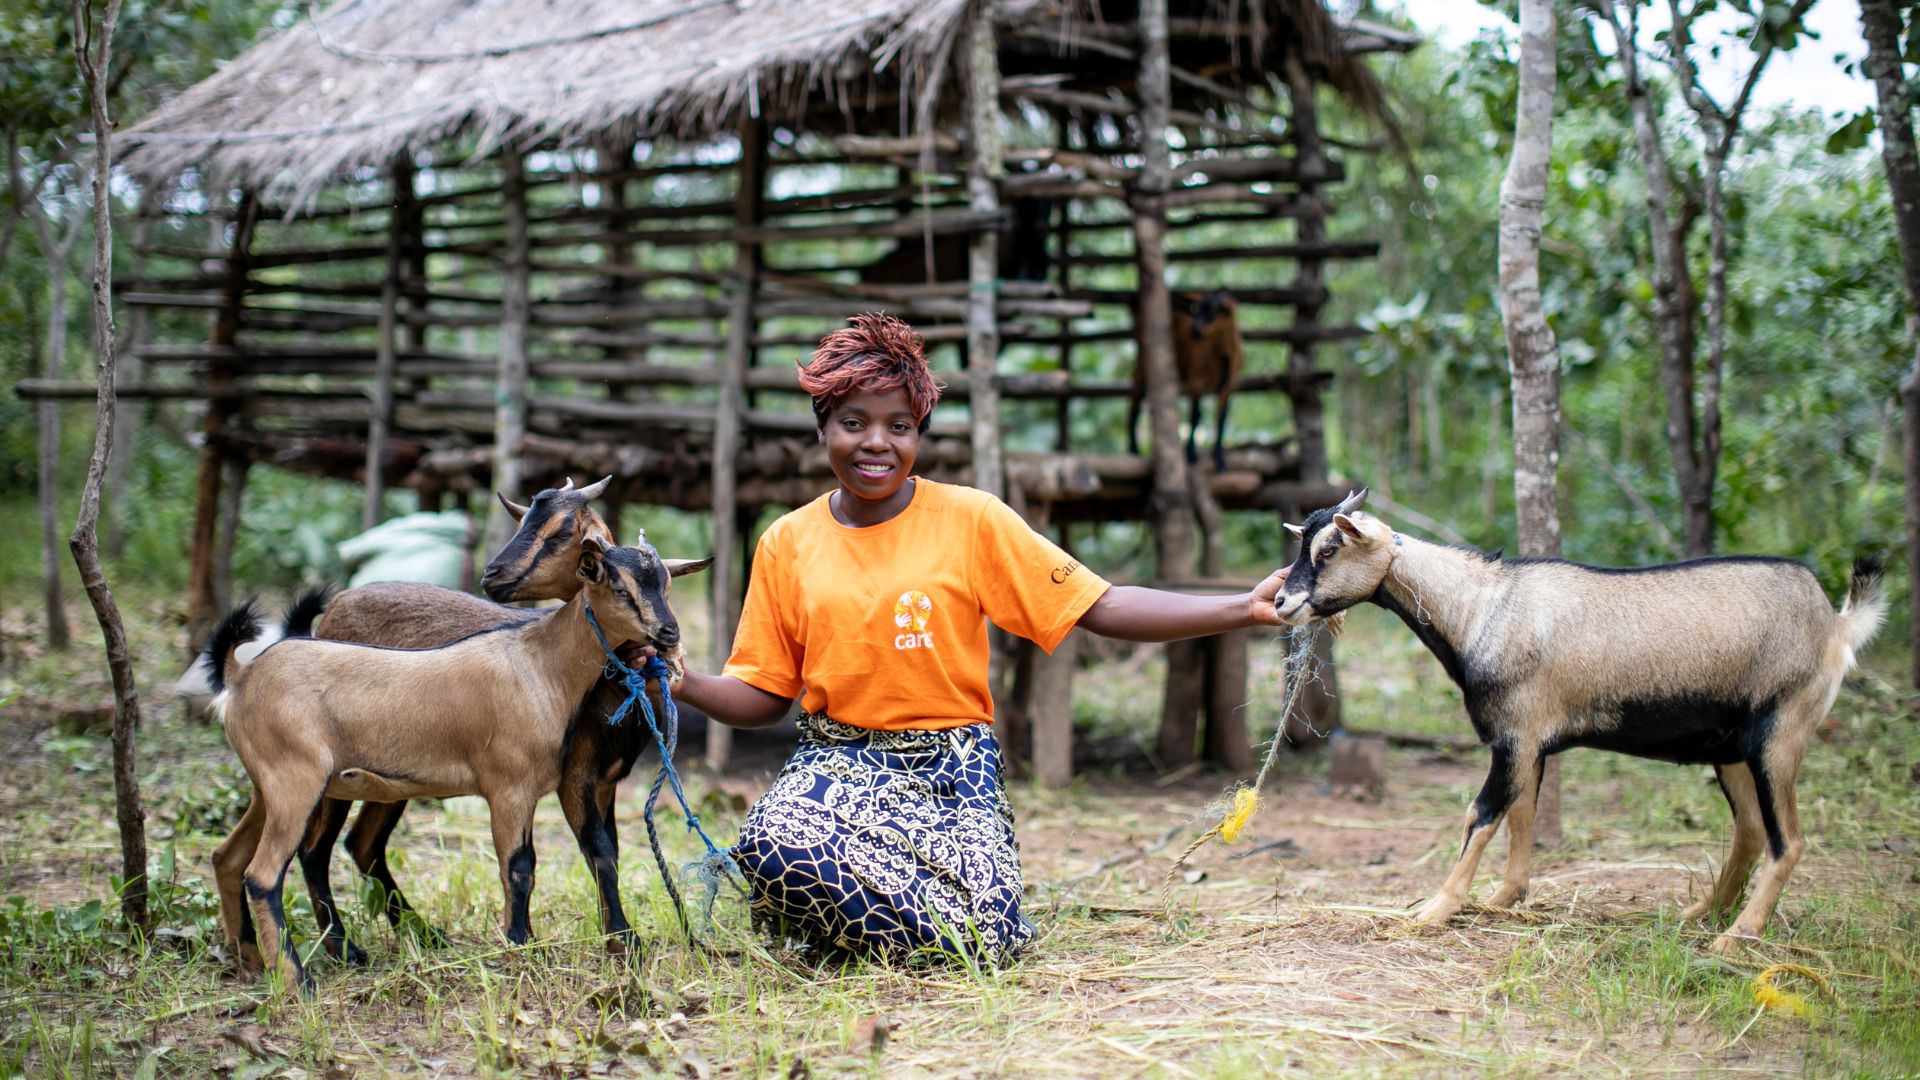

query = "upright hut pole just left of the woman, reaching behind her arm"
[707,117,766,771]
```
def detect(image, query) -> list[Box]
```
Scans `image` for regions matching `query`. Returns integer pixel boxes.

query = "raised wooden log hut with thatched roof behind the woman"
[56,0,1411,782]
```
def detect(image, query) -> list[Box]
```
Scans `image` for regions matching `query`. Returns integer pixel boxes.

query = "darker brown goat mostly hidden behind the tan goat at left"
[300,477,614,965]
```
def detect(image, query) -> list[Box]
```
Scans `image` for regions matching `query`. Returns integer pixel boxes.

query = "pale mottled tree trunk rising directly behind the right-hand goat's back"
[1500,0,1561,847]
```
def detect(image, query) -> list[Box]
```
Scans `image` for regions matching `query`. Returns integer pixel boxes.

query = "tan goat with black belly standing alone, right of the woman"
[1275,492,1885,951]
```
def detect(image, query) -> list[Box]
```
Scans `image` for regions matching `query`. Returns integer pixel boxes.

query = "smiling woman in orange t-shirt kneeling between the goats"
[678,315,1286,957]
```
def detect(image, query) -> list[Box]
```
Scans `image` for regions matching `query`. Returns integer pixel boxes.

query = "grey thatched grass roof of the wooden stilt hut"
[121,0,1379,196]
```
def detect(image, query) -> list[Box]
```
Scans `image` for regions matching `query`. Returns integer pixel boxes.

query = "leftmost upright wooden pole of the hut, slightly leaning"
[186,192,259,651]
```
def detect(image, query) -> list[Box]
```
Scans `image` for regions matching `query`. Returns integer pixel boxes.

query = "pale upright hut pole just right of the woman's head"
[966,0,1006,496]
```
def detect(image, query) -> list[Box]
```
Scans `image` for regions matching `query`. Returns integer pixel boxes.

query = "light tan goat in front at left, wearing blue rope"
[207,538,705,992]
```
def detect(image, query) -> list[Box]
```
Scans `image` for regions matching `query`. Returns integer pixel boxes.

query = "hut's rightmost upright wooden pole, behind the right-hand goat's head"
[1284,56,1340,751]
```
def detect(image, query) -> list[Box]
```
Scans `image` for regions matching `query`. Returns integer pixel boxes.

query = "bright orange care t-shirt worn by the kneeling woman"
[726,477,1108,730]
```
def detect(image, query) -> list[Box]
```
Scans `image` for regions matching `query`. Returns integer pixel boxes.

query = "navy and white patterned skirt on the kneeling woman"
[733,713,1033,959]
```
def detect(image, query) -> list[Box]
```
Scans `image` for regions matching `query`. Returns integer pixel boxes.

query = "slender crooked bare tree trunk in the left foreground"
[67,0,148,928]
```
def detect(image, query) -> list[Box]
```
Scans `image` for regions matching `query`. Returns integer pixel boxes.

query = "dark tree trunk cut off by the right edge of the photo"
[1860,0,1920,686]
